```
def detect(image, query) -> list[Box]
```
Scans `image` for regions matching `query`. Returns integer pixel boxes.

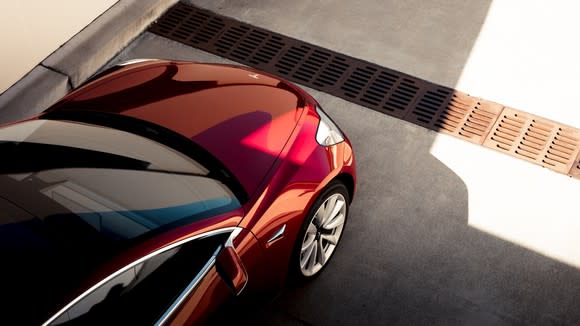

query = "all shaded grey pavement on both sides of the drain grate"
[86,0,580,325]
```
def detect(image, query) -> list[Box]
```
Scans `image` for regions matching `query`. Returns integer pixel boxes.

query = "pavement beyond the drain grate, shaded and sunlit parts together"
[193,0,580,127]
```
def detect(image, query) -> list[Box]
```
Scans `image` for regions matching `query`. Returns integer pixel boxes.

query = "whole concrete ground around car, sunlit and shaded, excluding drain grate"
[2,0,580,325]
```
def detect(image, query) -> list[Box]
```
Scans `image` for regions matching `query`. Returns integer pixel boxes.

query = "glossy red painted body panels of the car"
[4,60,356,324]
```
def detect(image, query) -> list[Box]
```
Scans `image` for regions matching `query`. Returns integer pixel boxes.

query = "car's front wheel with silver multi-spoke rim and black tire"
[289,181,350,281]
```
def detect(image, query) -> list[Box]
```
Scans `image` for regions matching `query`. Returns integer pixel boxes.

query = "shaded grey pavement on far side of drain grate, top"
[190,0,491,88]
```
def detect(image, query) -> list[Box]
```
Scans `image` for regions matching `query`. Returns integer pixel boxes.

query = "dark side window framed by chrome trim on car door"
[49,232,229,326]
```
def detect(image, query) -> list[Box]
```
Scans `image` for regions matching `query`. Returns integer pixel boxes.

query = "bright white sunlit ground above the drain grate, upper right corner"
[456,0,580,128]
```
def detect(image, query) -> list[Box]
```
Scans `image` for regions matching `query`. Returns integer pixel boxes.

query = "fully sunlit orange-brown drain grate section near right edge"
[484,108,580,174]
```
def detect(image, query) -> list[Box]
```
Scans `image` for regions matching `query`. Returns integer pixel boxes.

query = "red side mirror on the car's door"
[216,246,248,295]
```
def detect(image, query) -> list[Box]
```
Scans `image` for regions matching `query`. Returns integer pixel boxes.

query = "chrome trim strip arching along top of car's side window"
[42,227,240,326]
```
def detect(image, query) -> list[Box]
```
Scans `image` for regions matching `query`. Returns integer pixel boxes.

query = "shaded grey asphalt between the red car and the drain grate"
[104,33,580,325]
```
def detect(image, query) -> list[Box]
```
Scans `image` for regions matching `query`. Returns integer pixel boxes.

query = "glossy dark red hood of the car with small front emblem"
[48,60,305,196]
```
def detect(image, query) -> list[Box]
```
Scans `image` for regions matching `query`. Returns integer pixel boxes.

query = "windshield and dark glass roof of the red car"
[0,120,240,319]
